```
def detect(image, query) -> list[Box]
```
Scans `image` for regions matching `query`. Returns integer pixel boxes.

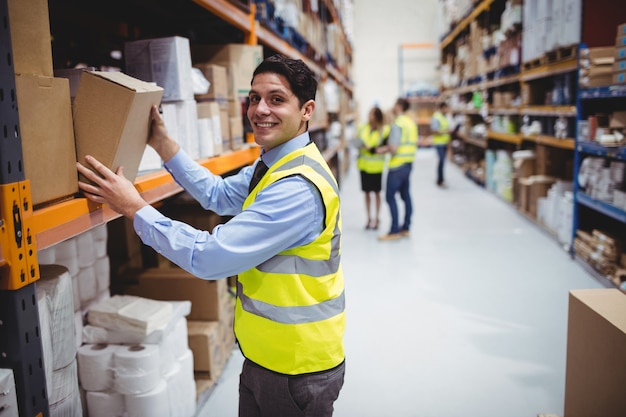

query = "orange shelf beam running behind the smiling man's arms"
[32,145,260,249]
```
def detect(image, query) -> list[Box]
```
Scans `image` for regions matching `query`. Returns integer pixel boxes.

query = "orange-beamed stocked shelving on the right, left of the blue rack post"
[441,0,623,249]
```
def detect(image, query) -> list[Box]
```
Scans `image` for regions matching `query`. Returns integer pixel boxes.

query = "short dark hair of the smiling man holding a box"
[252,55,317,107]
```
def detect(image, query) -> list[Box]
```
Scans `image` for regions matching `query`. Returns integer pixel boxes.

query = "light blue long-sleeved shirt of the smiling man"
[134,132,324,279]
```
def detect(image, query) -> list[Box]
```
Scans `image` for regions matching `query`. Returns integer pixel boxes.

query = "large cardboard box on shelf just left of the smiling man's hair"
[191,44,263,98]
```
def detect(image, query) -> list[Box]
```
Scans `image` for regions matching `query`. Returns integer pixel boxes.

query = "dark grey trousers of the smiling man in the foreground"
[239,359,345,417]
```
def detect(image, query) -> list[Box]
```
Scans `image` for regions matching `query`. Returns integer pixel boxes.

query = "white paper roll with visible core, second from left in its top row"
[113,345,161,395]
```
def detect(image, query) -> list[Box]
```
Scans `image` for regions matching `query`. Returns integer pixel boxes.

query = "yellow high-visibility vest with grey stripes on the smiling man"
[235,144,345,375]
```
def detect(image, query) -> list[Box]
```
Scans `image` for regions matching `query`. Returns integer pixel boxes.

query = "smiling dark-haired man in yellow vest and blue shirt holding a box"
[77,55,345,417]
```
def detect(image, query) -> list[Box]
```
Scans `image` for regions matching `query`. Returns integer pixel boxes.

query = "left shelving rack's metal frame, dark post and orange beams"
[0,0,353,417]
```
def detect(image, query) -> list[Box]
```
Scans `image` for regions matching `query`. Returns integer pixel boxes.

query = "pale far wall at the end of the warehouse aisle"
[353,0,440,121]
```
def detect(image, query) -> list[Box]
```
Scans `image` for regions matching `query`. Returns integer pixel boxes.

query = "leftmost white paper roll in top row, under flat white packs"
[78,344,117,391]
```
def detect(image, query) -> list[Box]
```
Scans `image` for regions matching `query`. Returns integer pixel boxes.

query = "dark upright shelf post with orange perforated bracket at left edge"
[0,0,50,417]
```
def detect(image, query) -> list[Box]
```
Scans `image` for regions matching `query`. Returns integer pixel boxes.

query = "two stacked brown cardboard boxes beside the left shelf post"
[8,0,78,205]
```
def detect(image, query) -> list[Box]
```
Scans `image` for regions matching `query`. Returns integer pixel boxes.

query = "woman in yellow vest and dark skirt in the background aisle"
[357,107,390,230]
